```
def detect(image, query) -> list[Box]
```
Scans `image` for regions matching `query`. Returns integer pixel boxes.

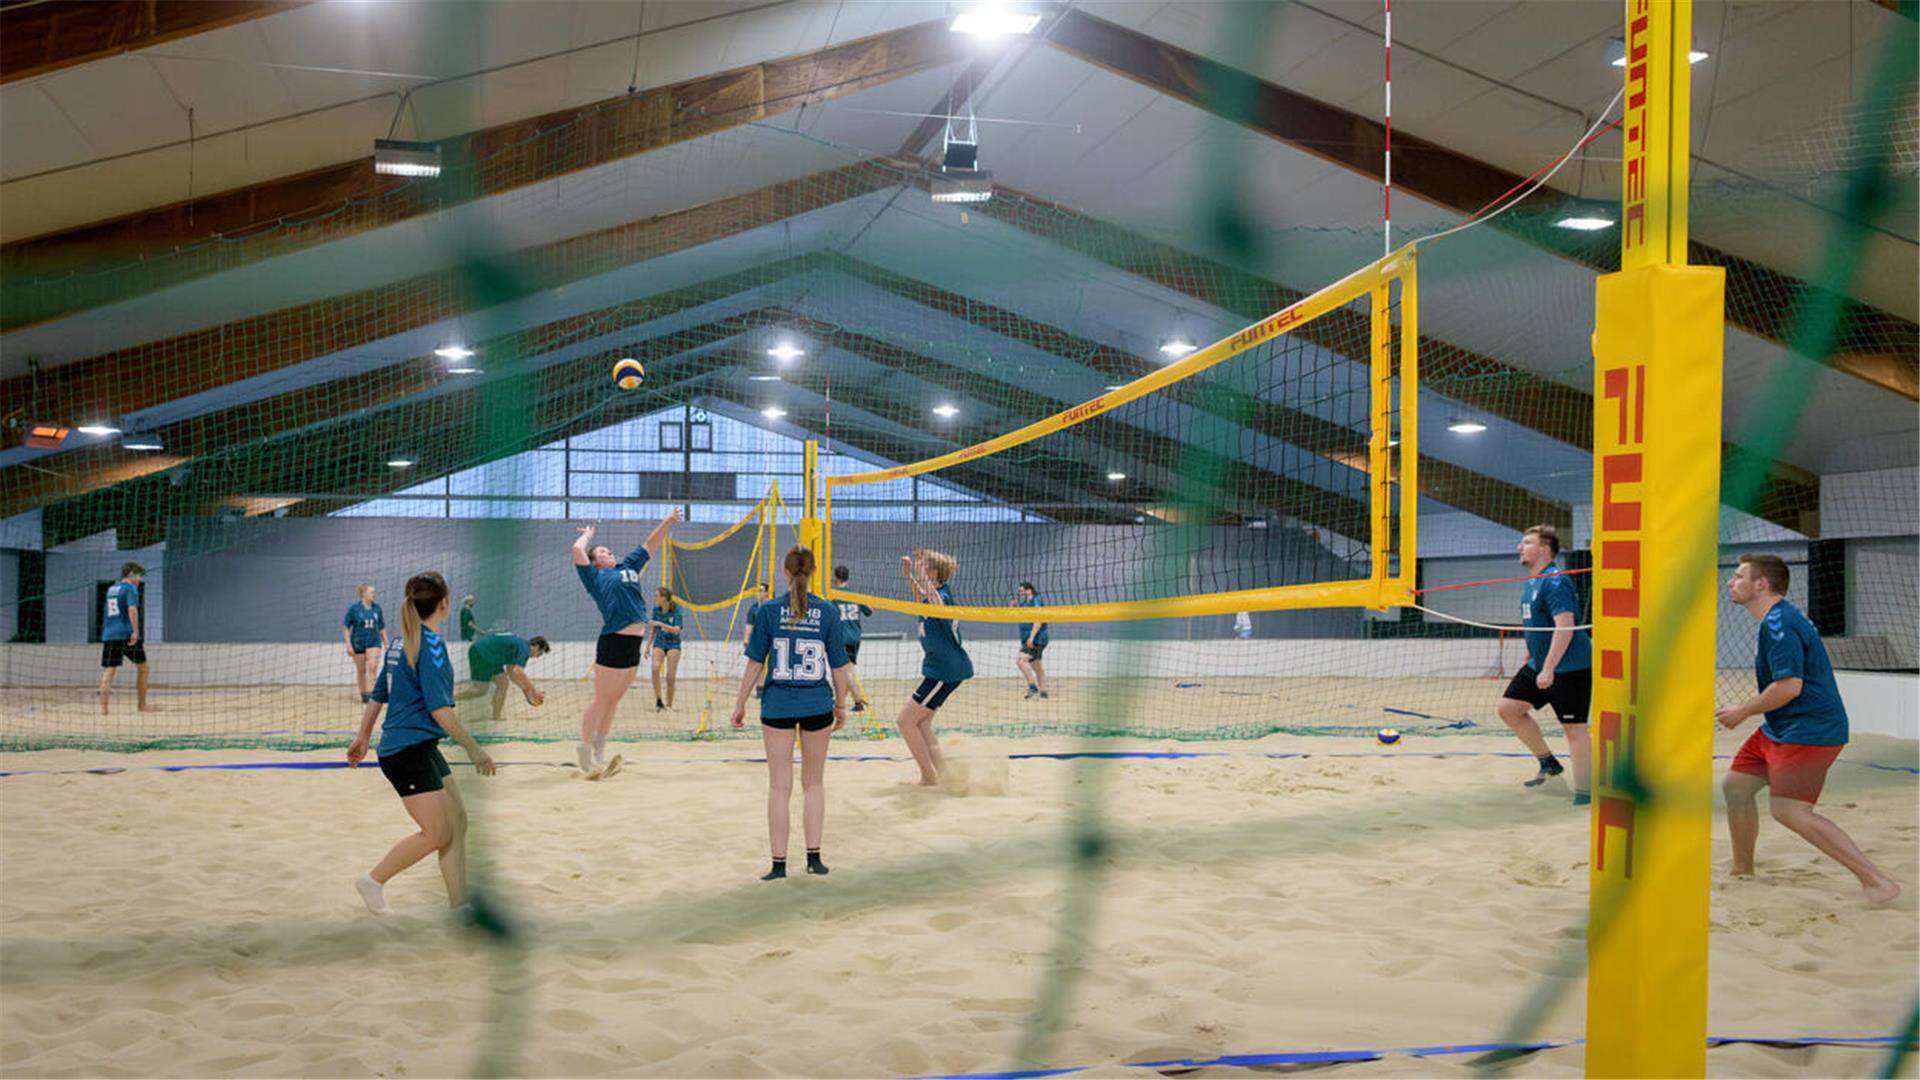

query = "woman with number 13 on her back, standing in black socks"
[733,548,852,882]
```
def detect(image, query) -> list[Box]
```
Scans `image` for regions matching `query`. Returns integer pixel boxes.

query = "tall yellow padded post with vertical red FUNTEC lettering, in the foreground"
[1586,0,1724,1076]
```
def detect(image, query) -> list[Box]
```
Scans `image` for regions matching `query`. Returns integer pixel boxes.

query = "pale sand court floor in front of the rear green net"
[0,722,1920,1076]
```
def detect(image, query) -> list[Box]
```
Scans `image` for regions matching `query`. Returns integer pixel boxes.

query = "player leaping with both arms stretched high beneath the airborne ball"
[574,507,680,778]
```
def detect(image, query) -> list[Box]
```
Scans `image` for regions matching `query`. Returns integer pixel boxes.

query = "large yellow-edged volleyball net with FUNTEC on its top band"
[818,248,1421,623]
